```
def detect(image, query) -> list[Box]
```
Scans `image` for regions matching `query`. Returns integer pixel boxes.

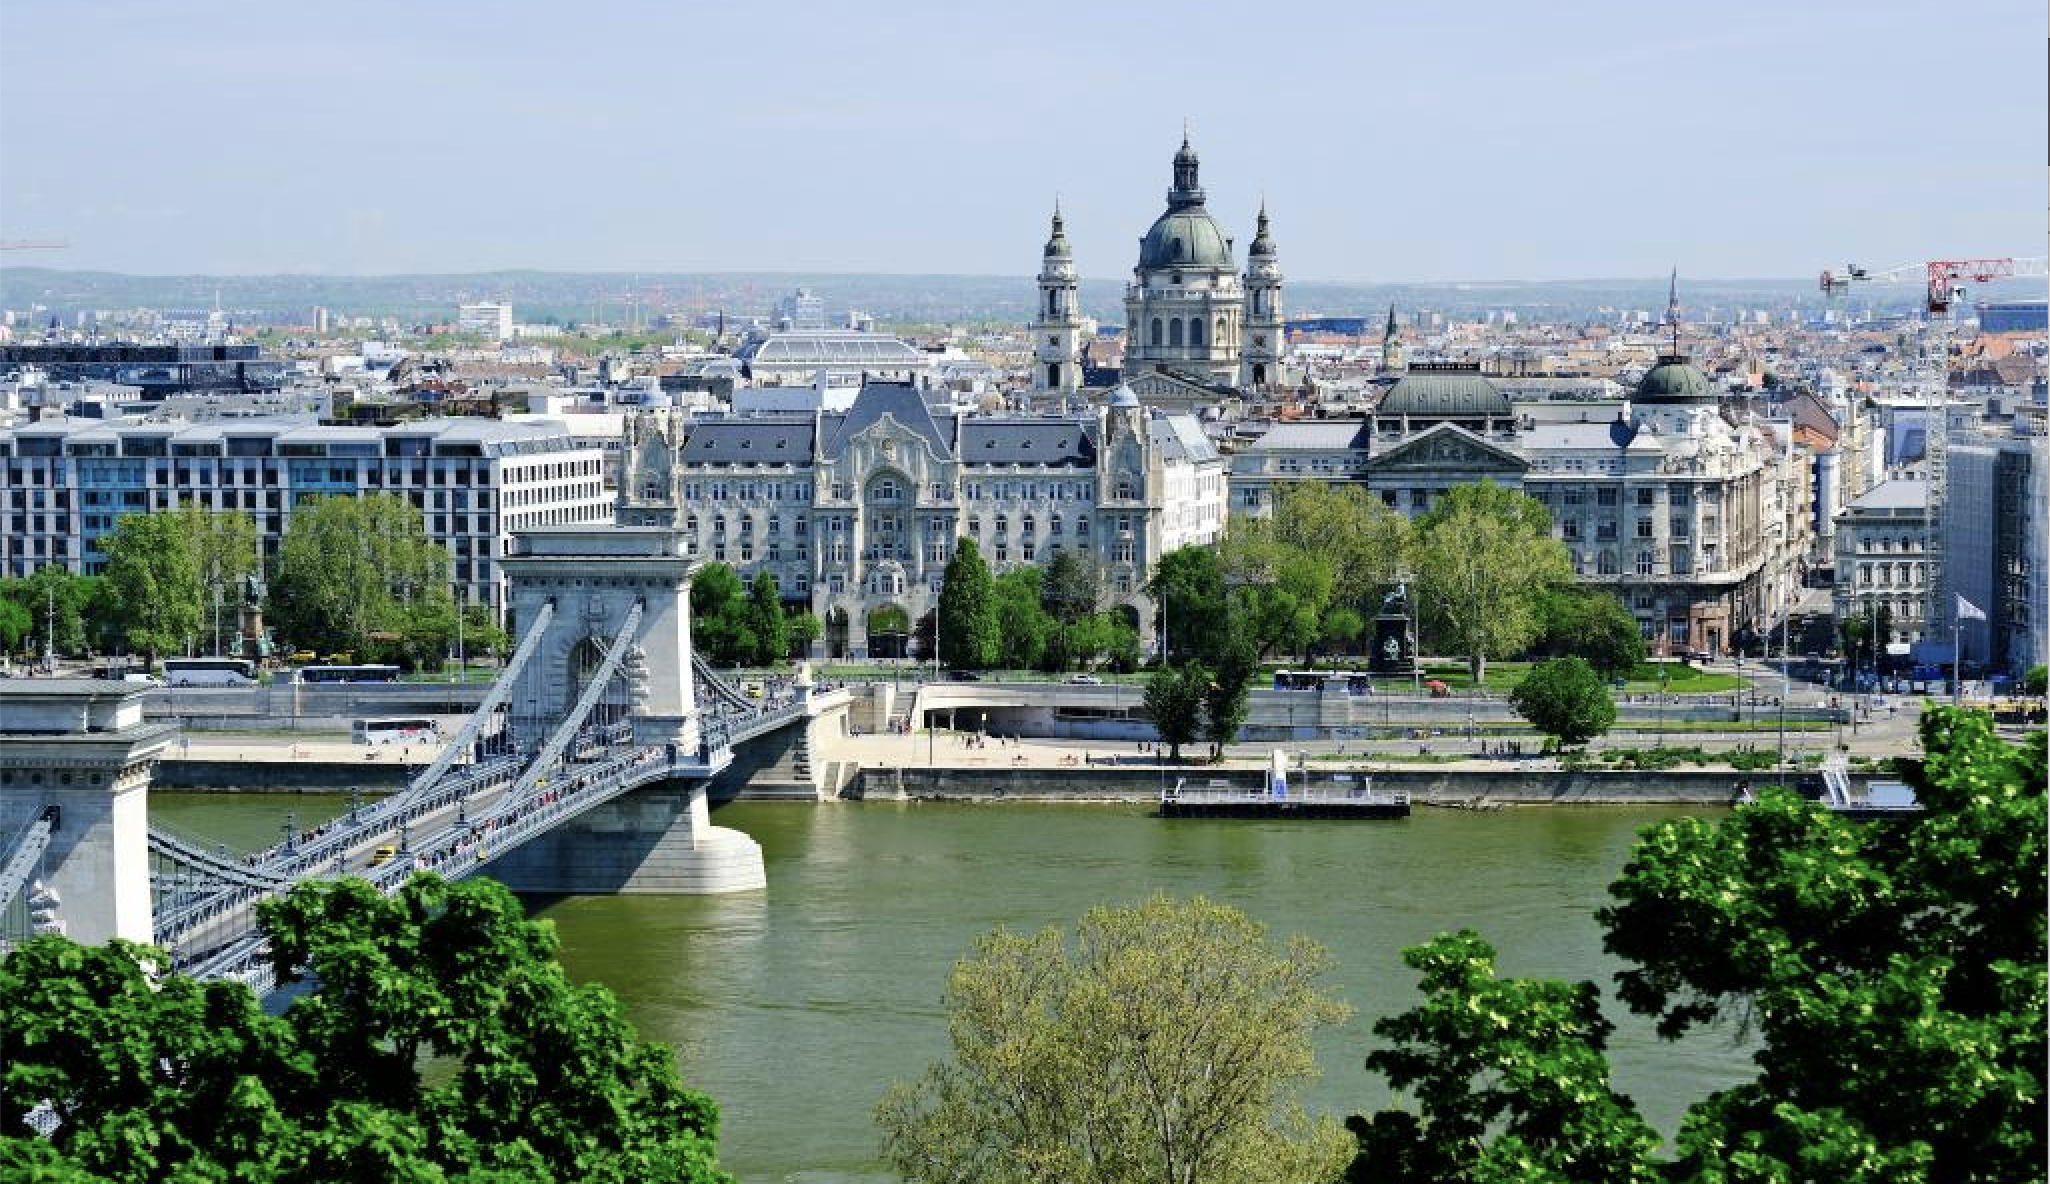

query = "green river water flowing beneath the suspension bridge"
[150,793,1749,1184]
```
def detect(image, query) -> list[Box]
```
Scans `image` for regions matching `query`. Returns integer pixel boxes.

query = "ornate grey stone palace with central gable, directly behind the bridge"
[619,381,1226,658]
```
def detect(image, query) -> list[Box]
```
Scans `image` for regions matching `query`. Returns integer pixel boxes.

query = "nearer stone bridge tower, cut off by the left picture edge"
[0,678,176,944]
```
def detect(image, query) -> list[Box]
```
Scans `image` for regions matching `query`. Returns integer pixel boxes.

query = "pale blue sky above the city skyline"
[0,0,2050,283]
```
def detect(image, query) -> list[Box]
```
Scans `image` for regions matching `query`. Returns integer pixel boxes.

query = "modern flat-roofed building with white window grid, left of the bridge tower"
[0,418,613,612]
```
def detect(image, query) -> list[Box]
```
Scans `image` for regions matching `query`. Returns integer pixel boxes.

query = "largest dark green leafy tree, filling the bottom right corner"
[1601,707,2050,1184]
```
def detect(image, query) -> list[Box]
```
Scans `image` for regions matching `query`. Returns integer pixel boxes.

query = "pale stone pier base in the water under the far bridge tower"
[488,780,769,895]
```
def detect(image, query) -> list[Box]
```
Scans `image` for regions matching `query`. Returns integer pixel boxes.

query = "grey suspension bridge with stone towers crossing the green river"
[0,526,845,991]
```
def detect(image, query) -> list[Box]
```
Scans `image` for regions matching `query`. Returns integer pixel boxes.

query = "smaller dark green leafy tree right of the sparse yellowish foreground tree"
[1347,930,1658,1184]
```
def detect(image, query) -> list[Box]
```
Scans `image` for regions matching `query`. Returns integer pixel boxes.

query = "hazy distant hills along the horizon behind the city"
[0,266,2017,324]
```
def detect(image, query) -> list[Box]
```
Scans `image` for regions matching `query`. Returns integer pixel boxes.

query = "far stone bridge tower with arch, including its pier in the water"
[492,524,767,895]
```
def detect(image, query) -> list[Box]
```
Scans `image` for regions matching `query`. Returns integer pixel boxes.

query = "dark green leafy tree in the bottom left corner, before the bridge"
[0,875,730,1184]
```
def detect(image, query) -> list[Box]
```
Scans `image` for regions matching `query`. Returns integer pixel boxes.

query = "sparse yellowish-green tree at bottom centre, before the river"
[875,895,1347,1184]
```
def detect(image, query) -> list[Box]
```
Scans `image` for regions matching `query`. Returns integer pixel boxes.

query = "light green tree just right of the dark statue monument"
[1412,481,1572,686]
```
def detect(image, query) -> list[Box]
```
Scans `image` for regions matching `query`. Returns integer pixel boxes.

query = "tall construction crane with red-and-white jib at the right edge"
[1822,256,2050,667]
